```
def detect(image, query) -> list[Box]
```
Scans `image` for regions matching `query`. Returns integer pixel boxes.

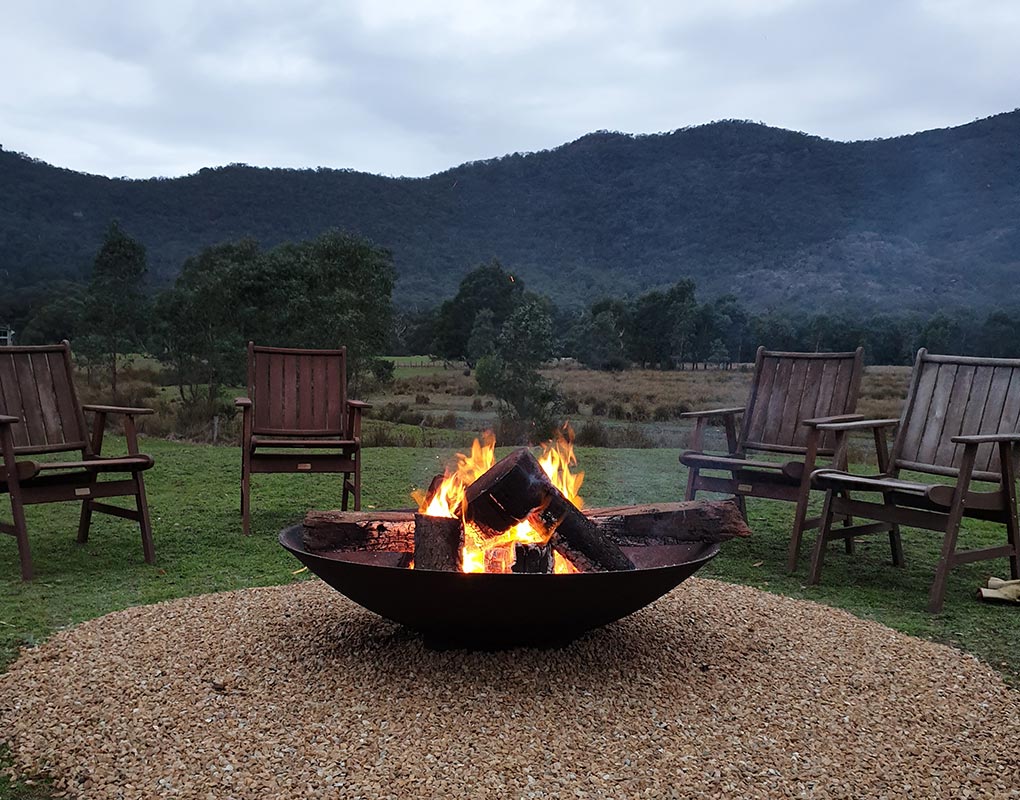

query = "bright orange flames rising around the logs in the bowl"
[411,424,584,574]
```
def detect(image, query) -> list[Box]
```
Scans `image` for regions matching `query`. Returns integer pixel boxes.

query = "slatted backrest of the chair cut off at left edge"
[0,342,90,455]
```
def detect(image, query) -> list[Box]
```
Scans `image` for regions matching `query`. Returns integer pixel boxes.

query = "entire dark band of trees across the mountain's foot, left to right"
[7,222,1020,410]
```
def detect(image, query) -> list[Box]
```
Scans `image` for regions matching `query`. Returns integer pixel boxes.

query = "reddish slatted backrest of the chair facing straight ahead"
[248,343,347,436]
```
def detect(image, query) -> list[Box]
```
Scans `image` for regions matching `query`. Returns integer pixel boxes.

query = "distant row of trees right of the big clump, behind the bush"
[391,261,1020,370]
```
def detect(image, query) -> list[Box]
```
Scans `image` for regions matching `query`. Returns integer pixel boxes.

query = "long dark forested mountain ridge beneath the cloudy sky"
[0,110,1020,310]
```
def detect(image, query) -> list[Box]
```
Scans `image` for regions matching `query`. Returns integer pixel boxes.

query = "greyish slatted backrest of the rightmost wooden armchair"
[893,348,1020,482]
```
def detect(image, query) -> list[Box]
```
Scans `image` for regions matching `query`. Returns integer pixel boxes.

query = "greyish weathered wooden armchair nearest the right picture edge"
[809,349,1020,613]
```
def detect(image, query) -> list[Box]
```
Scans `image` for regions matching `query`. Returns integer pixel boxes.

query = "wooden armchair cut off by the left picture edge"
[0,342,155,581]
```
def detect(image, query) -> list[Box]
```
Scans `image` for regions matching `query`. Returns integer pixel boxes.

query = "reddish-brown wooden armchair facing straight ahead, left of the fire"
[235,342,369,536]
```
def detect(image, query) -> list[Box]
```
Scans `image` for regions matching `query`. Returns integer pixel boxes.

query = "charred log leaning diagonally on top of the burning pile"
[466,449,634,571]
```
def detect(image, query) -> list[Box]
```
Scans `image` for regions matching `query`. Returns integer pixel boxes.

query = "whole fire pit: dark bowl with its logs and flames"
[279,428,750,647]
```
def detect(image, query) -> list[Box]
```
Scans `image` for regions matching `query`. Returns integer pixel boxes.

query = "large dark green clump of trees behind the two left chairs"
[0,222,395,419]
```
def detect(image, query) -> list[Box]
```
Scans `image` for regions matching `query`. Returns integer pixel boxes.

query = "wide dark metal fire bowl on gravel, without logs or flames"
[279,524,719,647]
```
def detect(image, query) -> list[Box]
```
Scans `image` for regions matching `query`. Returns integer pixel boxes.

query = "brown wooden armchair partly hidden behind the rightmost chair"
[680,347,864,571]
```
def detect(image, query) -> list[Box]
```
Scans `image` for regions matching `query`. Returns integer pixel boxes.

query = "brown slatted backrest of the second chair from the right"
[741,347,864,455]
